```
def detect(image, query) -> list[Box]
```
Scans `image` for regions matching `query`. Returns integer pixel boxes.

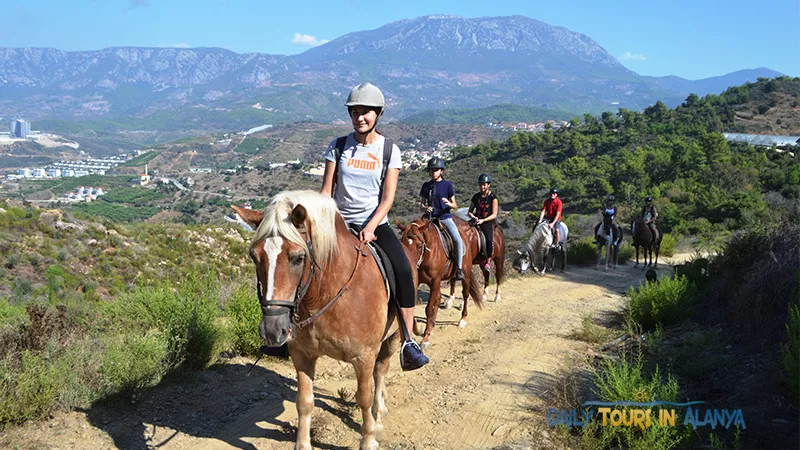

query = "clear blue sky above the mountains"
[0,0,800,79]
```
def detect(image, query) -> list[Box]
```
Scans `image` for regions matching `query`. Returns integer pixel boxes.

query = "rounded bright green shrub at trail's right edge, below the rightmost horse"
[626,276,693,329]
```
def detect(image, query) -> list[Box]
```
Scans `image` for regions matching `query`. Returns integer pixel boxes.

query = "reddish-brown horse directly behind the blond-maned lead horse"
[395,217,483,349]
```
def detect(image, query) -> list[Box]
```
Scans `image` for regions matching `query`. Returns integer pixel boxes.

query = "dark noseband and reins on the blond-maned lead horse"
[257,228,366,329]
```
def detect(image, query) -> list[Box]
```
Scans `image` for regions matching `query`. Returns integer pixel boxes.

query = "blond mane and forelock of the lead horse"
[251,190,339,264]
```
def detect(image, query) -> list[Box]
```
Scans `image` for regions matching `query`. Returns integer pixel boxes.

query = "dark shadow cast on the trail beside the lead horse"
[81,364,360,450]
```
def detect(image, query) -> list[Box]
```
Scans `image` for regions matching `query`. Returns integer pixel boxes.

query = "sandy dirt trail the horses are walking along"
[0,264,671,450]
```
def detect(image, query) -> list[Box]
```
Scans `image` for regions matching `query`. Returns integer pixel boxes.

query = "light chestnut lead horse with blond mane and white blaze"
[233,191,406,450]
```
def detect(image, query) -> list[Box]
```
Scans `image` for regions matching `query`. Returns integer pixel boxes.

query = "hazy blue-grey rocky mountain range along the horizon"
[0,15,781,127]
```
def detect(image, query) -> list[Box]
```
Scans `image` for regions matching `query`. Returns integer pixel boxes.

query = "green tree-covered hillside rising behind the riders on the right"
[390,77,800,250]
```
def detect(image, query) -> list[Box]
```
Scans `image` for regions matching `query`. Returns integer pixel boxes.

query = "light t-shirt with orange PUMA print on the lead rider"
[325,133,403,227]
